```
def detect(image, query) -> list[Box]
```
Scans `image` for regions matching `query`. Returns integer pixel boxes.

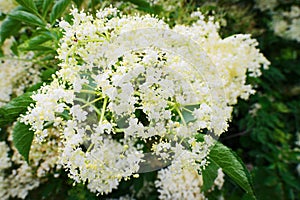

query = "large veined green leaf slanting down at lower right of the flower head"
[209,142,255,199]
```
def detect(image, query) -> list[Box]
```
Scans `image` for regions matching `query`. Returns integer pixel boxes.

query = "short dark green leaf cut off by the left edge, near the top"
[0,16,21,44]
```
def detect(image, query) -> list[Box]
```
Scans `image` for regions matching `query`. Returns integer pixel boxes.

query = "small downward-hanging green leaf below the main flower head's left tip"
[13,122,34,162]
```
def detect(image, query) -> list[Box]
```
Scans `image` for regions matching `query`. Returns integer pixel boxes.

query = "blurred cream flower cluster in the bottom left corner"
[0,128,61,199]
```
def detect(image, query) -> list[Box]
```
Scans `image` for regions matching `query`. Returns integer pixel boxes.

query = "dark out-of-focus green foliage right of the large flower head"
[218,3,300,199]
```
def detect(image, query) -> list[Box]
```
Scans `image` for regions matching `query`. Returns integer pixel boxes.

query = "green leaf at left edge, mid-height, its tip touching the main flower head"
[0,92,34,127]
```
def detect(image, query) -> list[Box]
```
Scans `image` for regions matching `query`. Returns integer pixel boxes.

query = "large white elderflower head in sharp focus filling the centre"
[21,8,269,195]
